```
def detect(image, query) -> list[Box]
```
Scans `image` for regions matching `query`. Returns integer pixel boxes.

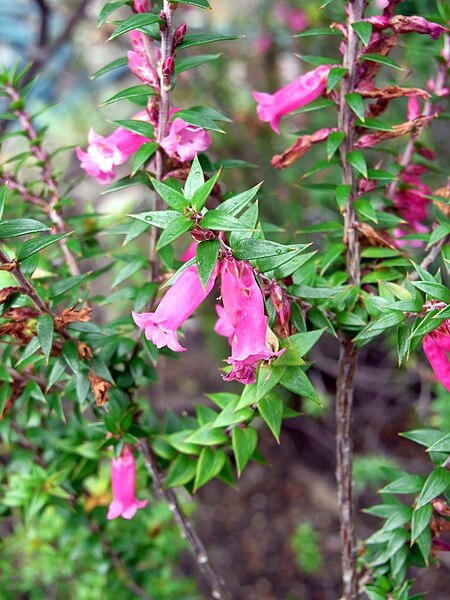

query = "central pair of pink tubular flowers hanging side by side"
[133,257,281,383]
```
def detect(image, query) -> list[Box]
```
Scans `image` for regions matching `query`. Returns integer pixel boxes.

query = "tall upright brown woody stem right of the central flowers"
[336,0,366,600]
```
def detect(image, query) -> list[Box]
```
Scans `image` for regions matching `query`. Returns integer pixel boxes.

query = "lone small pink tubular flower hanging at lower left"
[106,444,148,521]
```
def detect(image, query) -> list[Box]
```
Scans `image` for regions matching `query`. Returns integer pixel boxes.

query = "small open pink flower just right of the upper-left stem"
[161,117,211,162]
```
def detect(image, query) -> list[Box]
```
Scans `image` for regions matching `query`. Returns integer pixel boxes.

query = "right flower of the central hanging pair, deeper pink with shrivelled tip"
[215,258,281,384]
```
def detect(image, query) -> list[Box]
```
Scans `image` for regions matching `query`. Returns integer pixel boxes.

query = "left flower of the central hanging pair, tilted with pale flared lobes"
[132,265,218,352]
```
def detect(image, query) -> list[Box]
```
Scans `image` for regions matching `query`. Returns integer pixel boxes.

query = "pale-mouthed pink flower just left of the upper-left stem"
[76,113,149,185]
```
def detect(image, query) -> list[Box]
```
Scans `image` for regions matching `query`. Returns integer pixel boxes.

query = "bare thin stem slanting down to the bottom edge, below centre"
[136,440,231,600]
